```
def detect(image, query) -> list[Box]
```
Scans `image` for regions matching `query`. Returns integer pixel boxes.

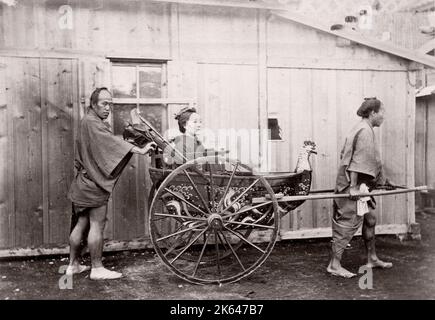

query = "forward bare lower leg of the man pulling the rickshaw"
[362,211,393,268]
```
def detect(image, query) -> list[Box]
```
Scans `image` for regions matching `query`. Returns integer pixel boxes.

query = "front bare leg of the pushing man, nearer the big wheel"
[88,205,122,280]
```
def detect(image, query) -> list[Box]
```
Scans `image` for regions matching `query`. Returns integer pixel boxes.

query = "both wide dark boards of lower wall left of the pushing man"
[1,58,78,247]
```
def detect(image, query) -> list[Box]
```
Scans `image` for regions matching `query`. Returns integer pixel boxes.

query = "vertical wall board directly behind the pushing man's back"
[41,59,78,243]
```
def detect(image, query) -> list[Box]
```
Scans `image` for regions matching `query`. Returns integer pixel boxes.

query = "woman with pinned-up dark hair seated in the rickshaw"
[164,107,207,165]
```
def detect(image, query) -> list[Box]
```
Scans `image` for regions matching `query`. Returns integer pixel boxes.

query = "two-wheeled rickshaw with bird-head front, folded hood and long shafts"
[124,111,426,284]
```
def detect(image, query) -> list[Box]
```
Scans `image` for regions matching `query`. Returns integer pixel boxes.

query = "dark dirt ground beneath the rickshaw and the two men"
[0,213,435,300]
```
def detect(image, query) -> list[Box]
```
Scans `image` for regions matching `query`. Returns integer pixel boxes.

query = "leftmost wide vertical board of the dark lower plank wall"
[6,58,43,247]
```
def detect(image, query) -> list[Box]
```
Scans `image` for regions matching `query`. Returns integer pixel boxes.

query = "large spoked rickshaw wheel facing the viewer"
[148,157,280,284]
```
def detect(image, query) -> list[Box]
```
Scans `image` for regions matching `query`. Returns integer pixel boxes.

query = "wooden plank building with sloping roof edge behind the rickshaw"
[0,0,435,256]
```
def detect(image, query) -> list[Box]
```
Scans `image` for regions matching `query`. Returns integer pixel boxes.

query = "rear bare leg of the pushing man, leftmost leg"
[66,215,90,274]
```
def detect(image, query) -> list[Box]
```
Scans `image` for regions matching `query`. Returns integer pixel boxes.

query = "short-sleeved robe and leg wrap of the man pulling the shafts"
[332,120,383,256]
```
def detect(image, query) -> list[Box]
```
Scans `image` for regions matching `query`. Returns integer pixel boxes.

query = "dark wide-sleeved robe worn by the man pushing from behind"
[68,109,133,208]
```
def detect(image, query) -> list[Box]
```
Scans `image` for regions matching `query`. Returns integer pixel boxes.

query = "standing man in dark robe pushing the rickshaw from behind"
[66,88,155,280]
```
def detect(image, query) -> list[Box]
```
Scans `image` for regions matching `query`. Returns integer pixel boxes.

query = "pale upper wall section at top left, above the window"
[0,0,169,59]
